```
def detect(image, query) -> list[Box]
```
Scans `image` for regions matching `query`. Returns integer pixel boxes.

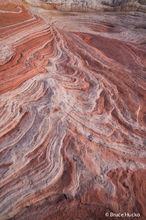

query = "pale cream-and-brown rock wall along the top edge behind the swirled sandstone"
[25,0,146,11]
